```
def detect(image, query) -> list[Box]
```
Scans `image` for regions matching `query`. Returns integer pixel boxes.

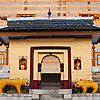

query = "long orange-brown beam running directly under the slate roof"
[0,30,100,36]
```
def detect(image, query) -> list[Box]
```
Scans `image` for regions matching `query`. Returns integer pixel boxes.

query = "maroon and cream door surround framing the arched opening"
[30,46,71,89]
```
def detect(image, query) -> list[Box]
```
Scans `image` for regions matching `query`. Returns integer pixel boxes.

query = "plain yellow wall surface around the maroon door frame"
[9,38,92,80]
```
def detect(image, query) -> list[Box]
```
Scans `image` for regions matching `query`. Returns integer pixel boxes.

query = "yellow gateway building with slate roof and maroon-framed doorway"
[0,0,100,97]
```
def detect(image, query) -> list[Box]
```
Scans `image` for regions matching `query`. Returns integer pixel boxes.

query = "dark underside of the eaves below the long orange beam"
[0,34,100,45]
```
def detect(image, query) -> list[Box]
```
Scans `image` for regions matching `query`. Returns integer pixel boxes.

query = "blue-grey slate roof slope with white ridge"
[2,17,100,31]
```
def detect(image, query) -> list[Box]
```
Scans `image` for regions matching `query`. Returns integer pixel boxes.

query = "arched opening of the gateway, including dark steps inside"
[41,53,61,89]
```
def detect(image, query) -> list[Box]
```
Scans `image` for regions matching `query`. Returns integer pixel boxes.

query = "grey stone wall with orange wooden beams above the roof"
[0,0,100,17]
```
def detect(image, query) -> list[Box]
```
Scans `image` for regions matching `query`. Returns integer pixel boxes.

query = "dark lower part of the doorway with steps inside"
[41,73,61,89]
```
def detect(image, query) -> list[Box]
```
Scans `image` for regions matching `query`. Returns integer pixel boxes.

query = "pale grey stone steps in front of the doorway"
[29,89,72,100]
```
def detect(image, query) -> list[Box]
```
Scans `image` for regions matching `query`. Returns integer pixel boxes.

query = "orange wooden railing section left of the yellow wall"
[0,46,9,65]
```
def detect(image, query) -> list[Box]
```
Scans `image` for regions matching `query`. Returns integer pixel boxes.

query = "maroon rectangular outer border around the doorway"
[30,46,72,89]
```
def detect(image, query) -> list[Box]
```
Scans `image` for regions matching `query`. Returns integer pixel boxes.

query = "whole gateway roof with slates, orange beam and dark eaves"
[0,17,100,44]
